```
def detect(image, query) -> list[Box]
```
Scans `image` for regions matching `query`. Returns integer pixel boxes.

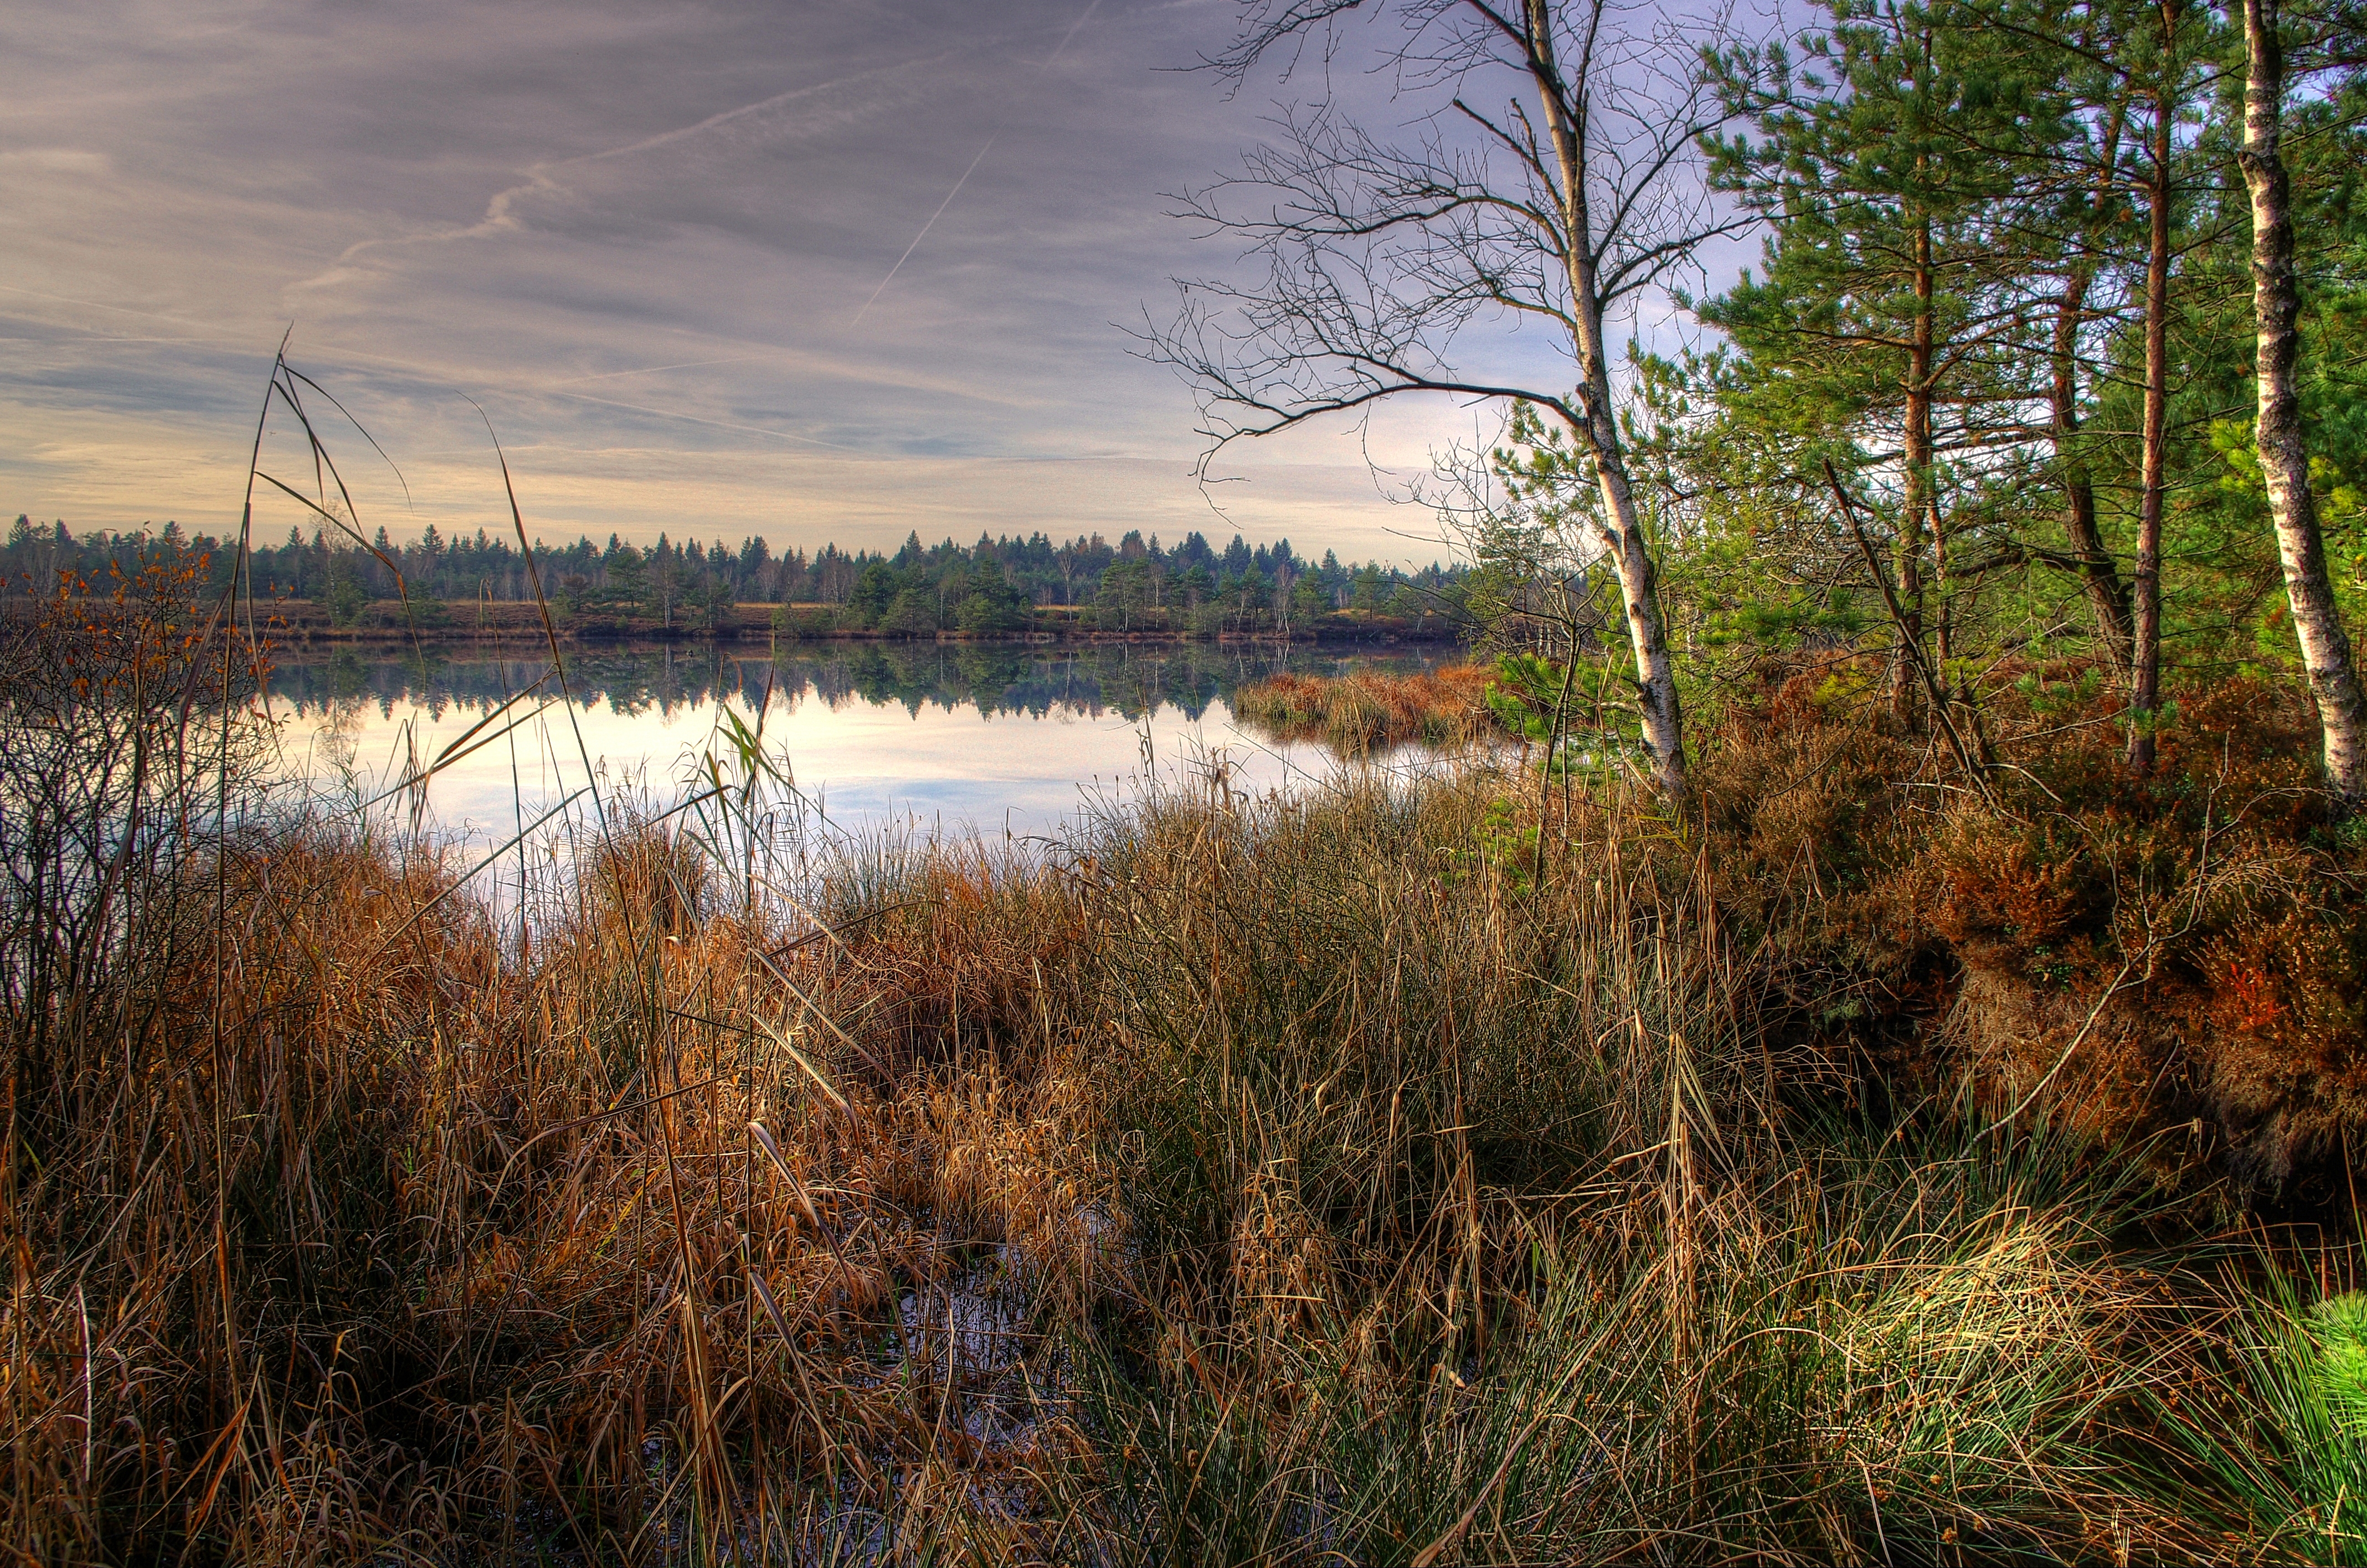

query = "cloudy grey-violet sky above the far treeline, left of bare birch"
[0,0,1742,563]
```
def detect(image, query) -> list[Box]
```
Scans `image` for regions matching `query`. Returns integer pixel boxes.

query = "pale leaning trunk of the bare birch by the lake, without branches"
[1527,0,1692,816]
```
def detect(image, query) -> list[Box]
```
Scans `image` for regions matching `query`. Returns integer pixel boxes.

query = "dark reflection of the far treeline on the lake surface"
[272,643,1437,719]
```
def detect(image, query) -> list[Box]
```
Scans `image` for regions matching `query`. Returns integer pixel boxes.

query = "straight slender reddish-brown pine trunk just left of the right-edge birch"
[2128,27,2178,778]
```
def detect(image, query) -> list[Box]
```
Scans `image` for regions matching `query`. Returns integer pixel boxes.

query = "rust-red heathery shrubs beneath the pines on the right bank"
[1702,667,2367,1185]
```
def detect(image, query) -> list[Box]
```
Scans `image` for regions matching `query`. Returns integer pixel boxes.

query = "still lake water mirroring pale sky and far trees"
[259,643,1437,839]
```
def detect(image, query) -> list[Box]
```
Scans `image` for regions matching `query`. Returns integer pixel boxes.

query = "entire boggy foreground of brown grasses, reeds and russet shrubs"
[0,657,2367,1563]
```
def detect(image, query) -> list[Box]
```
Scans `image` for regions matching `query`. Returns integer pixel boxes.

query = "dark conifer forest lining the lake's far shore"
[0,515,1468,634]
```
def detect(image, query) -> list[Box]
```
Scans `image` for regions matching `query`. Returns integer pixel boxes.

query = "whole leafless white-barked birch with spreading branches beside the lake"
[1152,0,1749,809]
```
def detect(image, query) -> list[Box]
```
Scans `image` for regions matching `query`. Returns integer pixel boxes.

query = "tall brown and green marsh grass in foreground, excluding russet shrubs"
[0,676,2348,1563]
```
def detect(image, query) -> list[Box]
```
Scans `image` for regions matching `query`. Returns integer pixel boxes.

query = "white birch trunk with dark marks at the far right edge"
[2237,0,2367,802]
